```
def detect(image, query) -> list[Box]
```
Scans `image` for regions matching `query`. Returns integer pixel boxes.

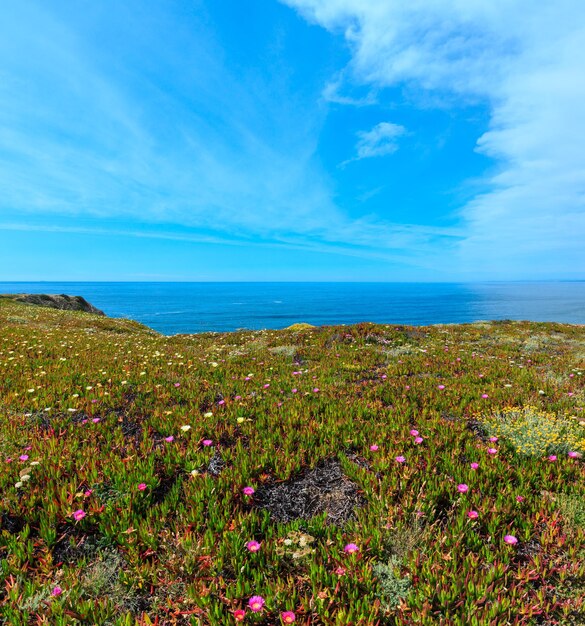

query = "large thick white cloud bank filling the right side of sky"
[285,0,585,278]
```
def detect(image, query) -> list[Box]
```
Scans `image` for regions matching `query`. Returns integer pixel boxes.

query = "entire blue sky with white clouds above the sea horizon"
[0,0,585,281]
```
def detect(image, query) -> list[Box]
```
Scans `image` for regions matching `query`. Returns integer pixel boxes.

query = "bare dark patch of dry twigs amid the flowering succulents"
[254,459,365,526]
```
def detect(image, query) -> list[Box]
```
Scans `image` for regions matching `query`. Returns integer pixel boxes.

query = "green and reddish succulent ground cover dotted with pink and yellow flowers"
[0,300,585,626]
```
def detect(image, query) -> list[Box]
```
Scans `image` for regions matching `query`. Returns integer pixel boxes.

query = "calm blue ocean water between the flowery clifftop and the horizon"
[0,281,585,335]
